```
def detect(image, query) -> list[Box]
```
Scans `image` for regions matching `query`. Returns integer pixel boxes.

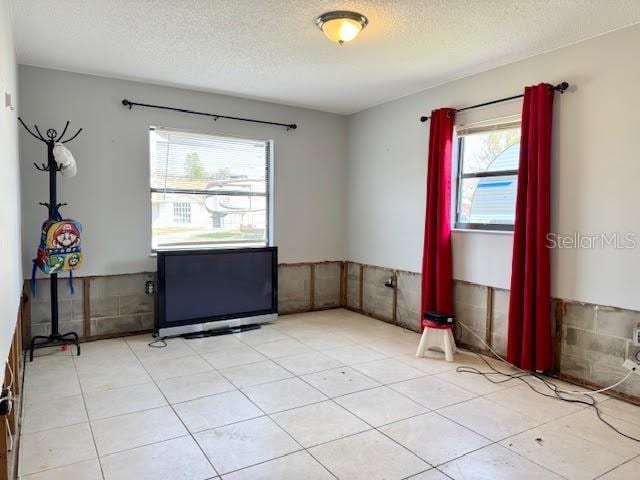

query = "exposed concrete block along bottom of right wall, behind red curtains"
[344,262,640,401]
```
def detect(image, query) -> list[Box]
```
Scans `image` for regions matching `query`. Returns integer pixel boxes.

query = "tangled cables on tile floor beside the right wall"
[456,322,640,443]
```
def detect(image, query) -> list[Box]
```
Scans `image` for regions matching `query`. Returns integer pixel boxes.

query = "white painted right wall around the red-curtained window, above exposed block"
[347,26,640,310]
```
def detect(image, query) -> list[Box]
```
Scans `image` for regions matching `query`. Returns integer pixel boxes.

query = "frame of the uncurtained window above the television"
[147,125,275,256]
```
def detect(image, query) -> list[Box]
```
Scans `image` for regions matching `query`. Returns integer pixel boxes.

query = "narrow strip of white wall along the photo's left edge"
[0,0,22,381]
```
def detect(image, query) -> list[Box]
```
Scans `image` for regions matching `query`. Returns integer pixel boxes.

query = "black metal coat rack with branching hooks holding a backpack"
[18,117,82,362]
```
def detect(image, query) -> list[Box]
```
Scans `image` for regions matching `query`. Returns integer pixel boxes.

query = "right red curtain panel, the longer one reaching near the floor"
[507,83,554,371]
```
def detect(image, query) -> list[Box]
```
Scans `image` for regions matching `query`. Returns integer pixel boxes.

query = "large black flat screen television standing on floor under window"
[156,247,278,335]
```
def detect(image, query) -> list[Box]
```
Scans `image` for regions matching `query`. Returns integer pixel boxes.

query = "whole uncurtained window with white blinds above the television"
[149,127,271,250]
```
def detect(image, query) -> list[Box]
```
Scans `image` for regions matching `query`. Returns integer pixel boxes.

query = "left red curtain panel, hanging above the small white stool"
[422,108,456,326]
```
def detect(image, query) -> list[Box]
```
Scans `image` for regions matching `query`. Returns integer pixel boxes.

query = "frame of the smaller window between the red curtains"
[453,119,522,232]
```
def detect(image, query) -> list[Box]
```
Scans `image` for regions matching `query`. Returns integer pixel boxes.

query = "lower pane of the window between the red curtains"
[458,175,518,225]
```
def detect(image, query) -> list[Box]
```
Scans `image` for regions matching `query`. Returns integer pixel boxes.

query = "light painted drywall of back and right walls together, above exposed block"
[17,25,640,310]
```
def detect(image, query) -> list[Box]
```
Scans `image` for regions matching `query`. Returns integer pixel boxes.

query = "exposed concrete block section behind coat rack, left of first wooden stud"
[24,275,85,336]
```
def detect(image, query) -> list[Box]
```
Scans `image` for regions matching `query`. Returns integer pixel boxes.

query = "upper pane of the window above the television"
[150,129,267,193]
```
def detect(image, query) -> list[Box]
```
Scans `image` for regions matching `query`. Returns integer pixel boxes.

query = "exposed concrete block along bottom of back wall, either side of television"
[25,262,342,338]
